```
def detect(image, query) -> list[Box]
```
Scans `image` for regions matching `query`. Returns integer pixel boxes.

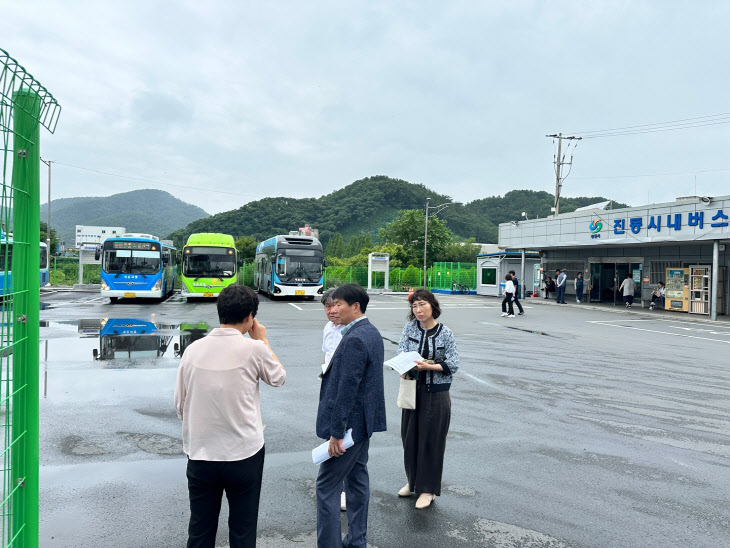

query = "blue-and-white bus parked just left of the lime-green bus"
[96,234,177,303]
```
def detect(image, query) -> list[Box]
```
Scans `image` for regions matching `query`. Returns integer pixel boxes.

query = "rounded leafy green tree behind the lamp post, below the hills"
[378,209,454,265]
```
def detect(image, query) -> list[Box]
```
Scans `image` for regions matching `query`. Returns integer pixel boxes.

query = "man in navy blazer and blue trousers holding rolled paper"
[317,284,386,548]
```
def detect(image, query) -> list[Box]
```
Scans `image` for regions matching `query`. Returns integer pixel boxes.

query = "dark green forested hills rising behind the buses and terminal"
[169,175,625,246]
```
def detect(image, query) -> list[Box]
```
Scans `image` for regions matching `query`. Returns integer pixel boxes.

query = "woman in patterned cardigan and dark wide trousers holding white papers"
[398,289,459,509]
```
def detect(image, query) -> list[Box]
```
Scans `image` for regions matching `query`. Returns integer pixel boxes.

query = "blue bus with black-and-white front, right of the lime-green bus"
[253,236,327,300]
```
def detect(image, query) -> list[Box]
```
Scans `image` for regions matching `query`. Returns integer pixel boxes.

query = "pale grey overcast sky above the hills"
[5,0,730,213]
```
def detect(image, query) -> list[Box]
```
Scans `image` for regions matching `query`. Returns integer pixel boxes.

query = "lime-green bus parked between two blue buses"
[181,232,242,299]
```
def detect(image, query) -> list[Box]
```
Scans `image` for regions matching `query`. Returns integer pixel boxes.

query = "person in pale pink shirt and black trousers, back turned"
[175,285,286,548]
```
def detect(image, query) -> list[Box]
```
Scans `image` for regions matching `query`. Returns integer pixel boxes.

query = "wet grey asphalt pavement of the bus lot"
[40,292,730,548]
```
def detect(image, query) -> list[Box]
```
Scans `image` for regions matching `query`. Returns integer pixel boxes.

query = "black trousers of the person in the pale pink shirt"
[187,447,265,548]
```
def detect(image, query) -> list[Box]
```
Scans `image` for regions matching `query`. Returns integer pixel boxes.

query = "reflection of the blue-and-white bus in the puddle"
[93,318,175,360]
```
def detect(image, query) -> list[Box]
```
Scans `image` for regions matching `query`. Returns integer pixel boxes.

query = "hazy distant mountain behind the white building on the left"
[41,189,209,246]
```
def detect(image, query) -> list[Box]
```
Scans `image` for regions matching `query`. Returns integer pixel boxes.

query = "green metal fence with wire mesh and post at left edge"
[0,49,60,547]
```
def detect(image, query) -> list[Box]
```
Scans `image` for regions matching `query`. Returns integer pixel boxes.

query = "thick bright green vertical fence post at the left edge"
[10,88,42,547]
